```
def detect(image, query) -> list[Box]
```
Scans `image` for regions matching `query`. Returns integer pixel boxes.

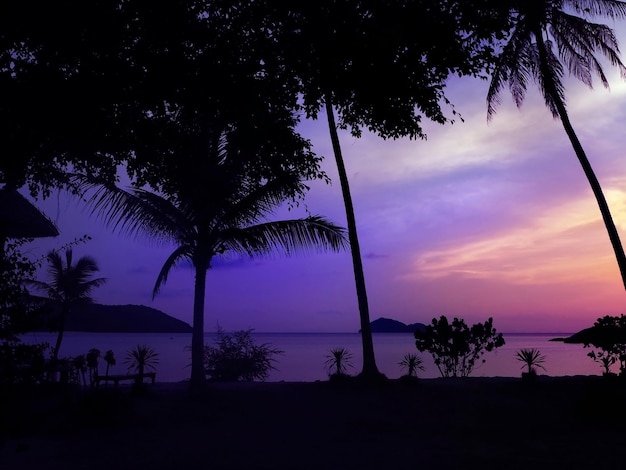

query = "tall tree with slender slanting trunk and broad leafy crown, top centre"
[281,0,508,379]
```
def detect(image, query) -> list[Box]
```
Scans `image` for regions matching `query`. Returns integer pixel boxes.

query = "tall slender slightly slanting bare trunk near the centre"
[326,94,380,378]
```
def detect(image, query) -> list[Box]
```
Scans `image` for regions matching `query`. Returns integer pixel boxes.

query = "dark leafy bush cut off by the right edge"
[583,314,626,374]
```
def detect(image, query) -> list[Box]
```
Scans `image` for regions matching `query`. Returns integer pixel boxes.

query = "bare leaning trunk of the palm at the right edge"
[536,33,626,289]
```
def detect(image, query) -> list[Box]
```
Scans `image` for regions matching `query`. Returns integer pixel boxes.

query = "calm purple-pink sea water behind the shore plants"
[18,332,600,382]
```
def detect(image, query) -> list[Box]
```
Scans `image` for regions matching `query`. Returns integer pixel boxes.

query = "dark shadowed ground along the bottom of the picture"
[0,377,626,470]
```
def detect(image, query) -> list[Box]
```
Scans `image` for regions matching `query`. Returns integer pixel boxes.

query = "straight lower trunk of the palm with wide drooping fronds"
[189,262,208,392]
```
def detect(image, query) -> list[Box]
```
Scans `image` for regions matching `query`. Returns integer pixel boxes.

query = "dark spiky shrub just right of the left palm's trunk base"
[204,327,284,382]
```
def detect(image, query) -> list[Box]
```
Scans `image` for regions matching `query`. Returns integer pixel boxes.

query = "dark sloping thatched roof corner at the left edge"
[0,187,59,238]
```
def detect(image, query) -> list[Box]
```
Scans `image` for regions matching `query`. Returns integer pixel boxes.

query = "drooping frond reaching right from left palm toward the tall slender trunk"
[221,216,348,257]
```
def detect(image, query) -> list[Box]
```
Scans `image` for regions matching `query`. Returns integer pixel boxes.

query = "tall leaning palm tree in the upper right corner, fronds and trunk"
[487,0,626,288]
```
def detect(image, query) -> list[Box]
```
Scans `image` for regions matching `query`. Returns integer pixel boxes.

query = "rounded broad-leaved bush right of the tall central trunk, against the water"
[415,315,504,377]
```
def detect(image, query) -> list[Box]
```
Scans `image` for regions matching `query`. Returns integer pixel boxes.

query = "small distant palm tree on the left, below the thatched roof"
[26,248,106,362]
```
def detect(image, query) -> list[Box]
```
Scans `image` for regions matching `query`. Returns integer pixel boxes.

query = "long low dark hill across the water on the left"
[36,304,192,333]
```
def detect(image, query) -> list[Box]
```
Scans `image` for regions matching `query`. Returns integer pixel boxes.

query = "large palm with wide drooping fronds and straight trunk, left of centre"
[77,132,346,390]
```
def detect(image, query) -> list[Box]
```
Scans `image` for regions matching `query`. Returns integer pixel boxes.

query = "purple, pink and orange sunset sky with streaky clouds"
[20,24,626,333]
